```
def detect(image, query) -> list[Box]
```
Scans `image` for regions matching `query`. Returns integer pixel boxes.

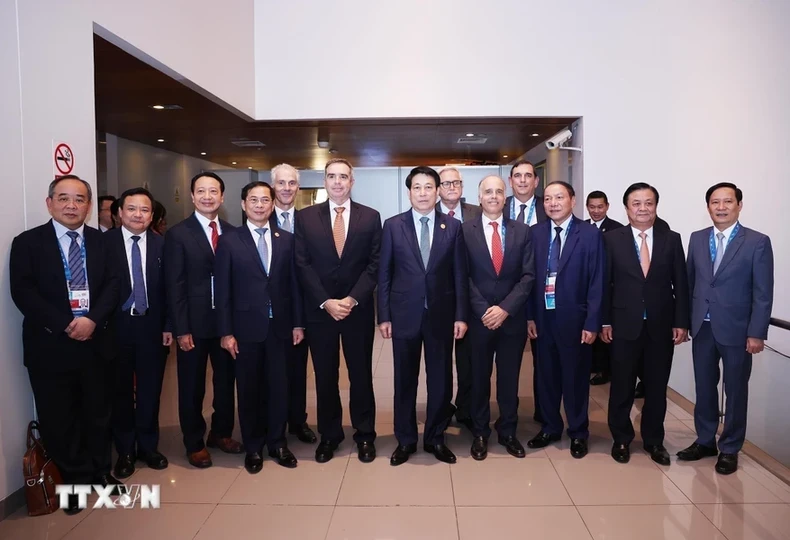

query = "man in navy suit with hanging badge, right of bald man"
[527,182,606,459]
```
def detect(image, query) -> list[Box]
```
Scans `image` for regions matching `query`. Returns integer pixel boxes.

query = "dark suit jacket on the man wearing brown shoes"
[165,214,234,339]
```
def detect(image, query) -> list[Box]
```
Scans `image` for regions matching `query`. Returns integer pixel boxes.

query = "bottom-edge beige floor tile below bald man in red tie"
[458,506,591,540]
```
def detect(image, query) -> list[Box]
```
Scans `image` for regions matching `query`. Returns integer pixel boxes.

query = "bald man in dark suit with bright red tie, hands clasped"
[463,176,535,460]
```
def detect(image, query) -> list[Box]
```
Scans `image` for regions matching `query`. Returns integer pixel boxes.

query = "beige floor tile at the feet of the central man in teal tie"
[337,453,458,506]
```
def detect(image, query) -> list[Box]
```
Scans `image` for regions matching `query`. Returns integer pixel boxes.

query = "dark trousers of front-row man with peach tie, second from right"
[609,323,675,446]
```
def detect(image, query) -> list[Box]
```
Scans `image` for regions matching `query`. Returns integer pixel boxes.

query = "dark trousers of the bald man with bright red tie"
[469,321,527,438]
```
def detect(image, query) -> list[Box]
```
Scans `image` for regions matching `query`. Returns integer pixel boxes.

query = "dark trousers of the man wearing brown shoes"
[177,337,236,454]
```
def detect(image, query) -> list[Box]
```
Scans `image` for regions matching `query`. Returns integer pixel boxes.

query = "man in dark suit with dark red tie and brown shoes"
[165,172,244,469]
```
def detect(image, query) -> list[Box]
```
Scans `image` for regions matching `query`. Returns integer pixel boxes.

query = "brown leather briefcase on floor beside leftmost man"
[22,421,63,516]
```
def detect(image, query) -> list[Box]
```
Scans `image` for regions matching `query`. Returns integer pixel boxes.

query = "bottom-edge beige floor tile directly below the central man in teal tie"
[326,506,458,540]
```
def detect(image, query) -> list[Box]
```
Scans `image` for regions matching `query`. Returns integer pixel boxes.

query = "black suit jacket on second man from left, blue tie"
[103,228,170,343]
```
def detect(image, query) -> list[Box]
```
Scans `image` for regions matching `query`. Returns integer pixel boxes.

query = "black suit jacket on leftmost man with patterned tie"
[10,220,118,372]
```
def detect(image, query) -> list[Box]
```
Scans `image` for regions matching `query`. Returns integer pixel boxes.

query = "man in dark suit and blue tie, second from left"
[104,188,173,478]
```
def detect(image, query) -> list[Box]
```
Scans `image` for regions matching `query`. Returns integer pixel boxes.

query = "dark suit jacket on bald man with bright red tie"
[462,217,535,334]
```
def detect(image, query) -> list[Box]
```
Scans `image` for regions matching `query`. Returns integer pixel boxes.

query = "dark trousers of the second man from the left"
[112,315,166,455]
